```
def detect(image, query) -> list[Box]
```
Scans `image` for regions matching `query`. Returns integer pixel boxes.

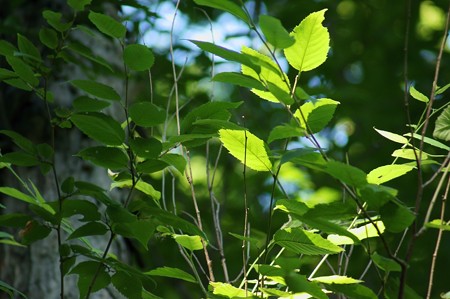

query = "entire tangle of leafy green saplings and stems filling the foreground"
[0,0,450,298]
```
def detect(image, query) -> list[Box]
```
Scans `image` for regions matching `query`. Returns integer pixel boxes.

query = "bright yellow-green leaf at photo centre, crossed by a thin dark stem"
[219,129,272,171]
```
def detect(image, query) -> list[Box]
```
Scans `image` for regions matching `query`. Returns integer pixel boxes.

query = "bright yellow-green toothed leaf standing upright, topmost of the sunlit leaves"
[284,9,330,72]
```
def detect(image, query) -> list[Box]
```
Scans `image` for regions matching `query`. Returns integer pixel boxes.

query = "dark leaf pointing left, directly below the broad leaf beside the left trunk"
[76,146,128,170]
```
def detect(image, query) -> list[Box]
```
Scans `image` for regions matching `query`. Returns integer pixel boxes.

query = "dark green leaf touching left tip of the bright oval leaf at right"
[325,160,367,188]
